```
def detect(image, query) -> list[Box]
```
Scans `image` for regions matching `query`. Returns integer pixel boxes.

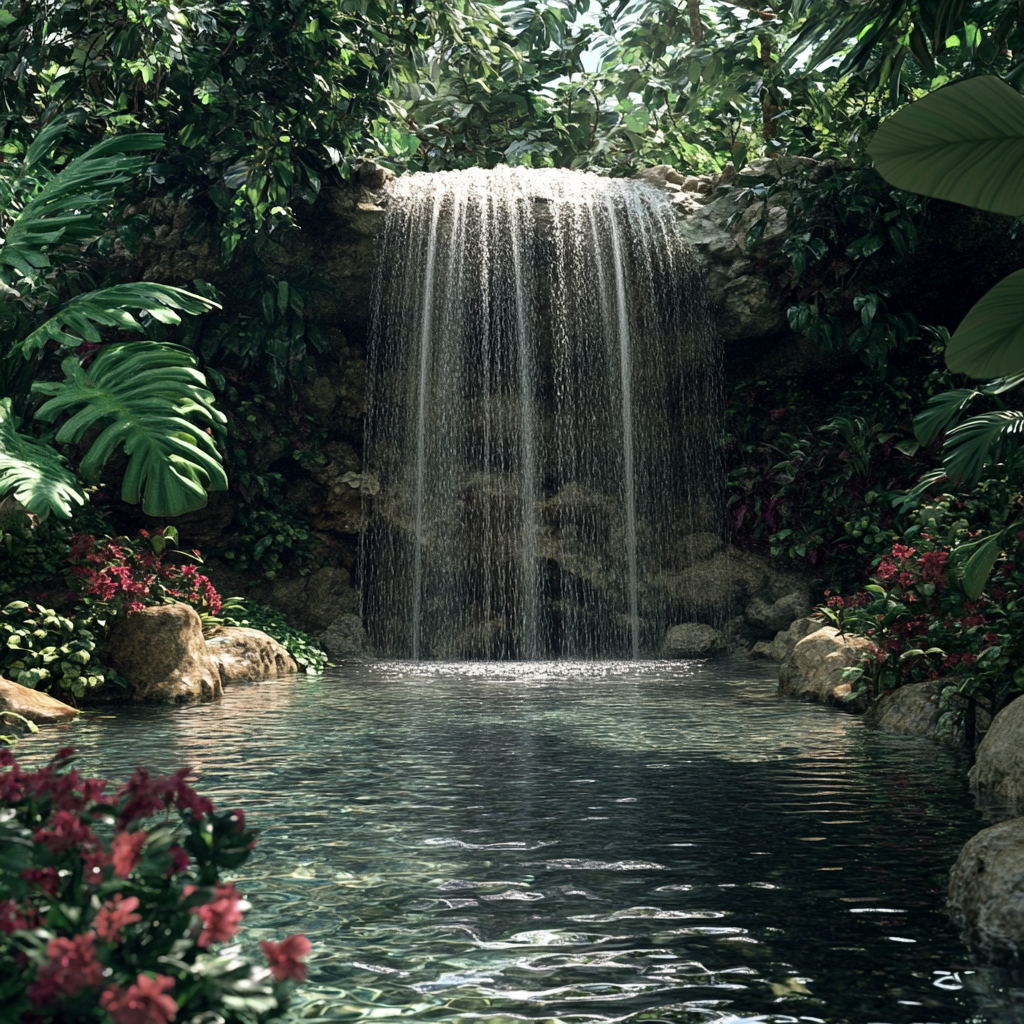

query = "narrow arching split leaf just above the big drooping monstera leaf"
[22,282,220,357]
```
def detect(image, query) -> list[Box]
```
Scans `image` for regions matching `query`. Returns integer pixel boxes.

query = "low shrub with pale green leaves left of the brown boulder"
[0,601,116,699]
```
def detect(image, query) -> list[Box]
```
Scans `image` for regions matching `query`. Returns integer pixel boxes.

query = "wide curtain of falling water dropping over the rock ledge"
[361,167,723,659]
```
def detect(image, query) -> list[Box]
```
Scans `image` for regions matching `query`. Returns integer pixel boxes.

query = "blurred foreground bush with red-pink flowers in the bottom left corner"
[0,749,310,1024]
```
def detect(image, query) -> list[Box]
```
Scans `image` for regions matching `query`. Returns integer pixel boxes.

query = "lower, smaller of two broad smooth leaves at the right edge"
[946,270,1024,377]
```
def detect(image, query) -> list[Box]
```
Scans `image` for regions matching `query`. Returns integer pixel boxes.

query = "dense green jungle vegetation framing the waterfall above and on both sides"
[0,0,1024,729]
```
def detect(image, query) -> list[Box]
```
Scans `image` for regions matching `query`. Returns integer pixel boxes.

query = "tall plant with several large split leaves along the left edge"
[0,122,226,518]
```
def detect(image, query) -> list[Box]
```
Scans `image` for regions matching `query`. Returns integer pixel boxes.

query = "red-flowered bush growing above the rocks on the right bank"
[821,496,1024,724]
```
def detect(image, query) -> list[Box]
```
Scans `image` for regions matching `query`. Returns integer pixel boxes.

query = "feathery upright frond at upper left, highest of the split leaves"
[0,126,164,286]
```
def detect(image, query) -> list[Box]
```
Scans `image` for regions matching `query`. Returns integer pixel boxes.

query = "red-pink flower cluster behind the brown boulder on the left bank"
[68,529,222,615]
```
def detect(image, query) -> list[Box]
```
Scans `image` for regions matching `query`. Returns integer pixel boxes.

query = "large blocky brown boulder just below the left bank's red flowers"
[108,604,223,703]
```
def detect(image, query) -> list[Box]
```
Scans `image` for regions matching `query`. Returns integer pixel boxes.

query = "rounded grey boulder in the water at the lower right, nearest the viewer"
[948,818,1024,962]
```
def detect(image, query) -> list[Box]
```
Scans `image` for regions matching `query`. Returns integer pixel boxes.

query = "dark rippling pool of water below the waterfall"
[20,663,989,1024]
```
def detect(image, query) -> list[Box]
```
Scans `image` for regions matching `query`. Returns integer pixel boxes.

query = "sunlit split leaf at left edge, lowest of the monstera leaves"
[0,398,85,519]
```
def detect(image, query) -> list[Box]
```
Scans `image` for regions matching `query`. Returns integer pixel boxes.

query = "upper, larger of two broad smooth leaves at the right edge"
[867,76,1024,218]
